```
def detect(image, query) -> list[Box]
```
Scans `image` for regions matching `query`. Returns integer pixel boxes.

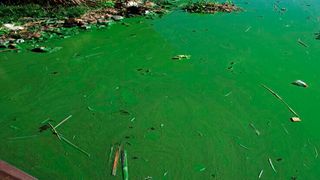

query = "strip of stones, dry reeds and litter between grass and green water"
[0,1,167,52]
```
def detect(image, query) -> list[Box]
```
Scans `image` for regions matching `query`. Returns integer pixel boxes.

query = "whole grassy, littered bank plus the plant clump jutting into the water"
[0,0,240,52]
